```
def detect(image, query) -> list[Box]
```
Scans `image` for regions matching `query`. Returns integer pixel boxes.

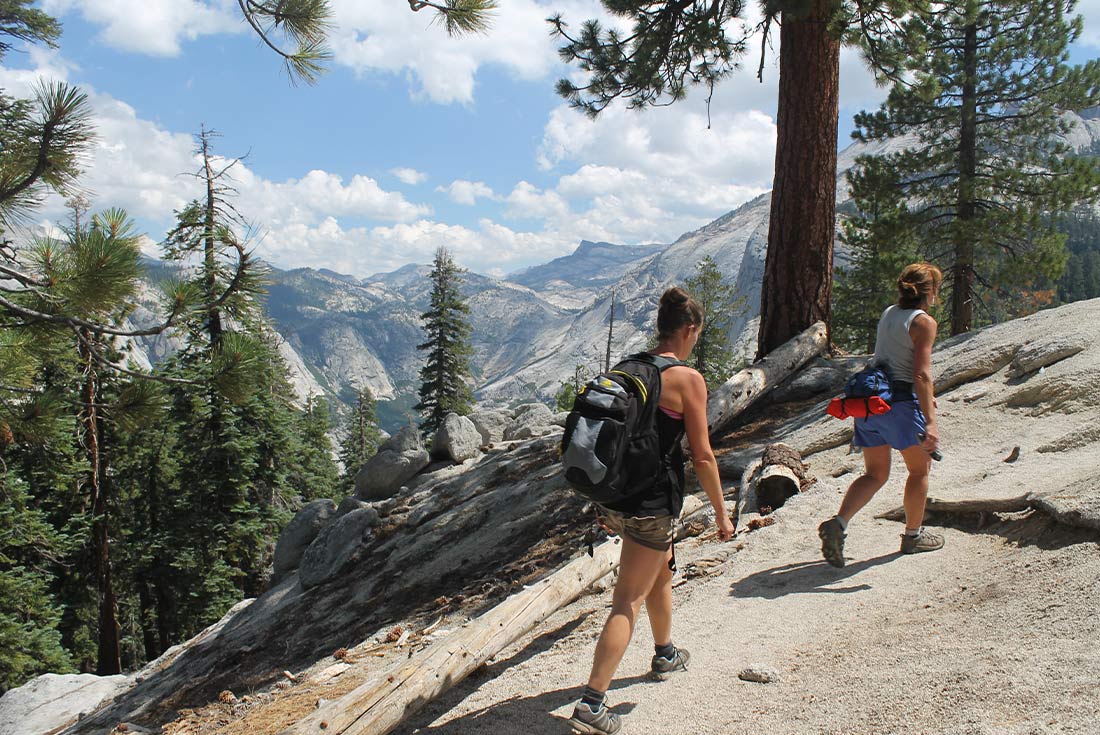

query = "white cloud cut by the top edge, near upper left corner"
[42,0,238,56]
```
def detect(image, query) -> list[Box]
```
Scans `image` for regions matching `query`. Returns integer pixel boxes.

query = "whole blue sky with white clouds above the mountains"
[0,0,1100,276]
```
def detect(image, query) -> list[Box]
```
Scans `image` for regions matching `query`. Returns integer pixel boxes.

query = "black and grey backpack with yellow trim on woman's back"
[561,352,686,505]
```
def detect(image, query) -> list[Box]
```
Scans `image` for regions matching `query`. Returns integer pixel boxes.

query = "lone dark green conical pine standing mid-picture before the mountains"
[416,248,473,434]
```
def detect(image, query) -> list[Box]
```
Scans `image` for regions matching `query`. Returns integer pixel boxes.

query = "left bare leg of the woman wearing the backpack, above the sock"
[589,537,671,691]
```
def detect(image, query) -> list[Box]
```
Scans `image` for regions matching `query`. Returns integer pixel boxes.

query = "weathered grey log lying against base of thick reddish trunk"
[706,321,828,435]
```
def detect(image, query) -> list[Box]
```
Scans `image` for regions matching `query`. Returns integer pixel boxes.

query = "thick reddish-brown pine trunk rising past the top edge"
[757,0,840,356]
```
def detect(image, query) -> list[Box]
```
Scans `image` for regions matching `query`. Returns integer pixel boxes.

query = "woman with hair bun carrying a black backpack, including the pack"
[562,288,734,735]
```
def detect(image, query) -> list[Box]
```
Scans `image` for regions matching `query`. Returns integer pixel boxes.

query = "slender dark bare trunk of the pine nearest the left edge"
[80,330,122,677]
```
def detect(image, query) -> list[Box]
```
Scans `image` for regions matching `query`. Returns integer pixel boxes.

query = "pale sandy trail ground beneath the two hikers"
[395,442,1100,735]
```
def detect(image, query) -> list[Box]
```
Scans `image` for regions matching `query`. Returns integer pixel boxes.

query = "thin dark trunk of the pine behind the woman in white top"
[952,17,978,334]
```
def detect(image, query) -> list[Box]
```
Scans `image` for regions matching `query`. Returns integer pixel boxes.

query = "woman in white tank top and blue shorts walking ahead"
[817,263,944,567]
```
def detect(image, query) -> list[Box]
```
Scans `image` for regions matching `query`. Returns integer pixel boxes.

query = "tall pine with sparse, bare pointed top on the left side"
[155,129,325,641]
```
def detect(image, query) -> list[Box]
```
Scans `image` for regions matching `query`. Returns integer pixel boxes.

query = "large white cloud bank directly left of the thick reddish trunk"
[538,99,776,242]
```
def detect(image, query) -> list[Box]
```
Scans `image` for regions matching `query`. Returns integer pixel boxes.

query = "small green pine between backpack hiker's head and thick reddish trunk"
[684,255,745,390]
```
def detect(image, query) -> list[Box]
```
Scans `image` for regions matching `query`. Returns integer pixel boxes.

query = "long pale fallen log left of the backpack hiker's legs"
[279,539,620,735]
